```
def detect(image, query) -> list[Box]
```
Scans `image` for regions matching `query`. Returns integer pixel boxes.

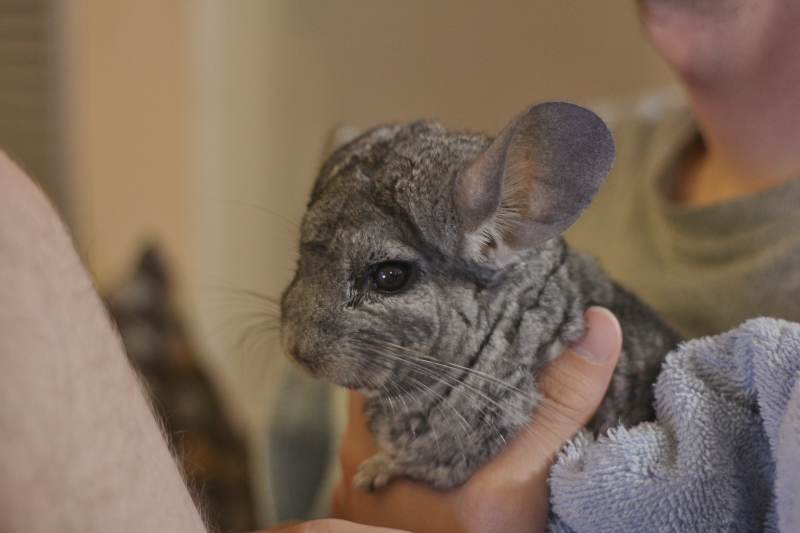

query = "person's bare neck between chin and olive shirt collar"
[674,75,800,206]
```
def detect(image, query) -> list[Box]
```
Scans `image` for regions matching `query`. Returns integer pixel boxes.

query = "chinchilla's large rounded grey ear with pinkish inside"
[455,102,614,266]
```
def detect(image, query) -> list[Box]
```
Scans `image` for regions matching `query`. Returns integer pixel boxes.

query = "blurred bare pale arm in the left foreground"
[0,153,205,533]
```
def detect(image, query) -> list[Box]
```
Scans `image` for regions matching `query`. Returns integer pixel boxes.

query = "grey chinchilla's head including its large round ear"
[281,103,614,391]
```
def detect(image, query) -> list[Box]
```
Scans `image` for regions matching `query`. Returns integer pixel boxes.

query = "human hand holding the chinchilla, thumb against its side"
[333,307,622,533]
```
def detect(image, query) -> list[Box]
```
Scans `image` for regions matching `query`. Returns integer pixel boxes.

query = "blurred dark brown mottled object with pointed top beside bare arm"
[106,247,256,532]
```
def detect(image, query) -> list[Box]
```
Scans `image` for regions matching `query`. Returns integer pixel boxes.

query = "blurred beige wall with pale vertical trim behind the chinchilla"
[64,0,669,434]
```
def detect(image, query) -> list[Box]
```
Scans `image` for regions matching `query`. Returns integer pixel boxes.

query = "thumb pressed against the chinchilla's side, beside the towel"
[531,307,622,454]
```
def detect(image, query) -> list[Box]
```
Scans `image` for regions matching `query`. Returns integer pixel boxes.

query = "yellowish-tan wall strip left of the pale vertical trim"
[62,0,191,294]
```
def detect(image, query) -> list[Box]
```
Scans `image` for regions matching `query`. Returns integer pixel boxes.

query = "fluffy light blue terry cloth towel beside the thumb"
[550,318,800,532]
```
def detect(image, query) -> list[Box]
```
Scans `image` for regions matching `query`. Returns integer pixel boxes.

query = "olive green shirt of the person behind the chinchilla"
[566,91,800,338]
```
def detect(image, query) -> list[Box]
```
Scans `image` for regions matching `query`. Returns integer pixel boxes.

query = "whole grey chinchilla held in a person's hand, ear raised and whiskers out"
[281,102,678,490]
